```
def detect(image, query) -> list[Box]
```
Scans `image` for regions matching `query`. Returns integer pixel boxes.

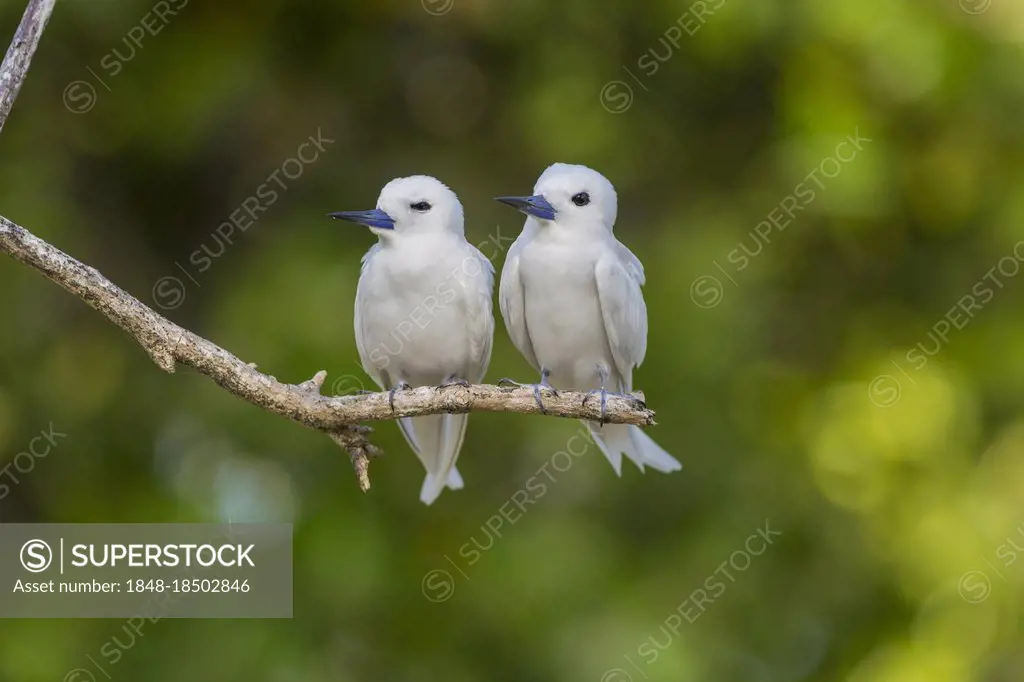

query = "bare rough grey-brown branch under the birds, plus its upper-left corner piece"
[0,0,654,491]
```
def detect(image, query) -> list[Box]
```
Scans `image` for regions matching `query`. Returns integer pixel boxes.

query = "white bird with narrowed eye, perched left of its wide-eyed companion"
[330,175,495,505]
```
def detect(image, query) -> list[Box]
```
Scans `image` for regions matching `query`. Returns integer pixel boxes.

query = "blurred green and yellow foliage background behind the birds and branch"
[0,0,1024,682]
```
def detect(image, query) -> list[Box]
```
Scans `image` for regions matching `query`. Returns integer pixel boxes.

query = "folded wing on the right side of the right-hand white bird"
[594,242,647,391]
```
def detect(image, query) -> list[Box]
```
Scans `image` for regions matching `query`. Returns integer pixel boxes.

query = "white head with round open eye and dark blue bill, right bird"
[496,164,618,232]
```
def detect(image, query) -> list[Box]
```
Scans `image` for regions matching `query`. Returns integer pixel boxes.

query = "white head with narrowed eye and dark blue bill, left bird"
[328,175,465,239]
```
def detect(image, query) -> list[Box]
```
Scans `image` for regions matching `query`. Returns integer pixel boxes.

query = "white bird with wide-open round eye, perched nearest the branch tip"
[498,164,682,475]
